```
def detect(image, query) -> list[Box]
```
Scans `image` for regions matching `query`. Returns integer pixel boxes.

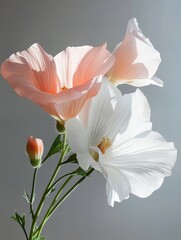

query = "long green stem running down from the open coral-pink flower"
[29,134,67,240]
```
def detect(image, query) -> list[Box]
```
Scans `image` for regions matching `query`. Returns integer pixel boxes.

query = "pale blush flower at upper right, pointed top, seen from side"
[107,18,163,87]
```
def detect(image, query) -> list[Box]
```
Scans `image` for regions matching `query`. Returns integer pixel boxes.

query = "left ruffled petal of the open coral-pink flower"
[1,43,60,99]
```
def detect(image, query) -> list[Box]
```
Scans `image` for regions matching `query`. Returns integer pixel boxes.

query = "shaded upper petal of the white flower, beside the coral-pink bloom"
[80,78,134,146]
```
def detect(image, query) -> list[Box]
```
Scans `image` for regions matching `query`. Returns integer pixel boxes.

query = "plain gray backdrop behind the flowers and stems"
[0,0,181,240]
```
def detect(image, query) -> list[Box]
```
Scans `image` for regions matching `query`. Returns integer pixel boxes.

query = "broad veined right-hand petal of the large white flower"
[105,132,176,197]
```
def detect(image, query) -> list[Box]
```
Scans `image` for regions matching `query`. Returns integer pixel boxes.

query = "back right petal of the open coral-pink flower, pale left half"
[55,44,114,88]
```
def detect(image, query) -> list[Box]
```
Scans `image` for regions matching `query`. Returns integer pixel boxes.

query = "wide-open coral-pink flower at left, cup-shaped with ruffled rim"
[1,43,114,121]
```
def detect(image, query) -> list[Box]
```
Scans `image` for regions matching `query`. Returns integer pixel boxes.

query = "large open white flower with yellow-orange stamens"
[66,79,176,206]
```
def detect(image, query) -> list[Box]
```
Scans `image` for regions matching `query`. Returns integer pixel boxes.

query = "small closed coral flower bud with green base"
[26,136,44,168]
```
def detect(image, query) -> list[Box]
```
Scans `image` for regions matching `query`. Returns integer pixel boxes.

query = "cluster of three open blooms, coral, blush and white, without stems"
[1,19,176,206]
